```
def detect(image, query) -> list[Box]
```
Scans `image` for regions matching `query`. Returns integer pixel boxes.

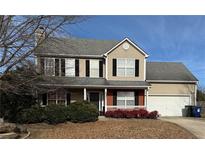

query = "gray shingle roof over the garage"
[146,62,198,81]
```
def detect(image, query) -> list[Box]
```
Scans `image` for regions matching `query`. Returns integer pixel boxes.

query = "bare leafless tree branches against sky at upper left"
[0,16,83,76]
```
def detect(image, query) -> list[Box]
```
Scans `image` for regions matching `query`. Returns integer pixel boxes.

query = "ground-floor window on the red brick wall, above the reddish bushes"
[117,91,135,108]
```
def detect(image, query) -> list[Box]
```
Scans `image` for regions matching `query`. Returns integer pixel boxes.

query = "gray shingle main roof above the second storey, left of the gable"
[35,38,118,57]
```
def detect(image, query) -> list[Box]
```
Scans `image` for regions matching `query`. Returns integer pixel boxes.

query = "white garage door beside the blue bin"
[147,96,190,116]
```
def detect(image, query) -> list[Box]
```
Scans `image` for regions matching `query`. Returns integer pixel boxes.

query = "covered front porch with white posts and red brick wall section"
[40,88,148,114]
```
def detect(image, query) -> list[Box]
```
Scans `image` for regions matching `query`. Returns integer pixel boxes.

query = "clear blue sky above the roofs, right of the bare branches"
[67,16,205,87]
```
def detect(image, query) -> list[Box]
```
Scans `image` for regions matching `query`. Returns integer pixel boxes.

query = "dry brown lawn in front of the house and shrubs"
[27,119,196,139]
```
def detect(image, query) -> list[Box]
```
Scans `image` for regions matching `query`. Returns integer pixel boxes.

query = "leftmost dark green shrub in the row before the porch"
[15,106,46,123]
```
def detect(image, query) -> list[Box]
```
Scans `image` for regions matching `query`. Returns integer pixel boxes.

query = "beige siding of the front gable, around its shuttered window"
[107,41,145,81]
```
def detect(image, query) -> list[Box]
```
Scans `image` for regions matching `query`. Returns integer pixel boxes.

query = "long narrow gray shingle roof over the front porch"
[38,77,150,88]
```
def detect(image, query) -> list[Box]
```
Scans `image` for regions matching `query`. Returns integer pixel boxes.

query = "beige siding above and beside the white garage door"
[149,83,195,104]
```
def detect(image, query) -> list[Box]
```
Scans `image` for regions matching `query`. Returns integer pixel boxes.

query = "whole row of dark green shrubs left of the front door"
[15,102,98,124]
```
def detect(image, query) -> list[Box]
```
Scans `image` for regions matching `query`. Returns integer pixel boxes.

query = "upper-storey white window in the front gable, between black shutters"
[117,58,135,77]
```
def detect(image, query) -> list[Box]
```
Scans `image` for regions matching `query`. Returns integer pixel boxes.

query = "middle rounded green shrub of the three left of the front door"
[44,104,69,124]
